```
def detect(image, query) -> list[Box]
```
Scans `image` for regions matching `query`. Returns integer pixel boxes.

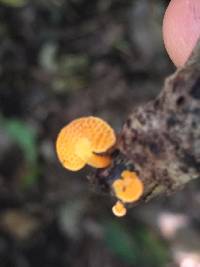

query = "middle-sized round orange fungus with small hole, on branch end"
[112,170,144,203]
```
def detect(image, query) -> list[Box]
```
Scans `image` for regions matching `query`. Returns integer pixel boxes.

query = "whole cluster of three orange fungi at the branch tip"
[56,116,143,217]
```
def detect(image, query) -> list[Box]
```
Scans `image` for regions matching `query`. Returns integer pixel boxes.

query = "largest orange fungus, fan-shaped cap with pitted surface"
[56,116,116,171]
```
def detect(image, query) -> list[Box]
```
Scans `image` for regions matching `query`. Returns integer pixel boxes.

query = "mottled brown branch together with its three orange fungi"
[56,40,200,217]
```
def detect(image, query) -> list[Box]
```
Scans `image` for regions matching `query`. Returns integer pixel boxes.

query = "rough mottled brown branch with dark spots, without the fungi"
[92,40,200,203]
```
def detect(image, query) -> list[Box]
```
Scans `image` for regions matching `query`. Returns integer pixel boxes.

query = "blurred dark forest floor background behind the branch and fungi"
[0,0,200,267]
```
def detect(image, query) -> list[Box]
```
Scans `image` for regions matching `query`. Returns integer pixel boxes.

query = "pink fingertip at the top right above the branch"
[163,0,200,67]
